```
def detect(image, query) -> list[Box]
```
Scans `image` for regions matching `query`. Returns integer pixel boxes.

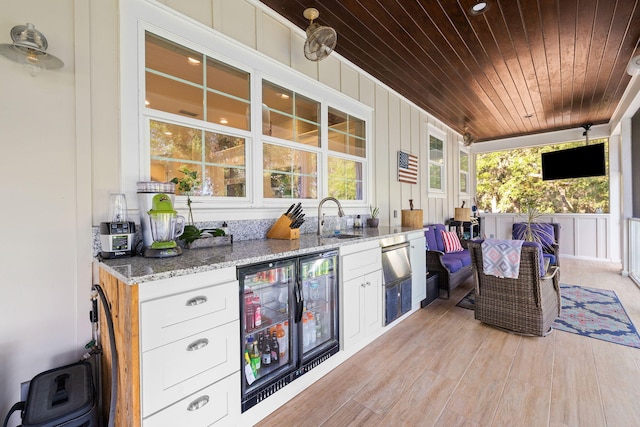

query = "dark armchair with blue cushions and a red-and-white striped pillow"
[424,224,473,299]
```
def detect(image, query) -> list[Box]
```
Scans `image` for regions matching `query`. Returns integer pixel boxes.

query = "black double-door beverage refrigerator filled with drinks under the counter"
[238,250,340,412]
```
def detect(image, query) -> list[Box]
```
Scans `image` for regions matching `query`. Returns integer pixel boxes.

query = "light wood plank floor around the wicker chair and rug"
[259,259,640,427]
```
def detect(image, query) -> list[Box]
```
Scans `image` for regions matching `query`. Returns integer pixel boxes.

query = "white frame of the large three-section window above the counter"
[120,14,373,221]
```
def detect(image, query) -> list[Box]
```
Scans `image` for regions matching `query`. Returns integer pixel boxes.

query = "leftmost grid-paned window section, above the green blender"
[145,33,251,197]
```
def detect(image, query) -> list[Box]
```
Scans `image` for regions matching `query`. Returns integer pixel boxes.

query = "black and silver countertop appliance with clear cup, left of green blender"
[100,193,136,258]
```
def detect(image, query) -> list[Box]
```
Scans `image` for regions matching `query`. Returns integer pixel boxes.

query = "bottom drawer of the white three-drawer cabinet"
[142,373,240,427]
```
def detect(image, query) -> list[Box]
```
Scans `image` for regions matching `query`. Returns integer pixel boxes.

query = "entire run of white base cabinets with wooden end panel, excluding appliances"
[100,232,426,427]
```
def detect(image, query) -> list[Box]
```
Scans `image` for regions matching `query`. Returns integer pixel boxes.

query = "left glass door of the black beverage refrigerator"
[239,261,296,393]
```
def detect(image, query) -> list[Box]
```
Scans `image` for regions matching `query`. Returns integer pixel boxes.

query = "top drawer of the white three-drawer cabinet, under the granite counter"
[140,281,240,352]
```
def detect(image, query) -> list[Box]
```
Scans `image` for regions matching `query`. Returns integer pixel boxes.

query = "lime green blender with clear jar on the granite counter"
[144,193,185,258]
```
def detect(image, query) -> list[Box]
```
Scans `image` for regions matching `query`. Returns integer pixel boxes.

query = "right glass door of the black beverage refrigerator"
[300,252,338,358]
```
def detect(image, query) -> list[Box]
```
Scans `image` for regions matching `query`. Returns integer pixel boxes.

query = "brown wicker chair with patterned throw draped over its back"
[469,240,562,336]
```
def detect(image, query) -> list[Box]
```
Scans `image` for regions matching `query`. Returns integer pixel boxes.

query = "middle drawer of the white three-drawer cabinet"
[141,320,240,417]
